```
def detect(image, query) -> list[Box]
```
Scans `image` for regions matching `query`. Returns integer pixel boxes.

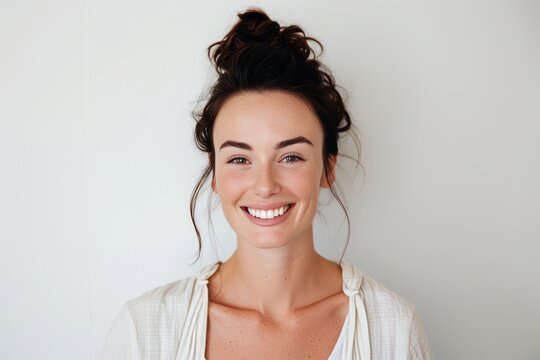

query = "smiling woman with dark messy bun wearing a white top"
[102,10,431,360]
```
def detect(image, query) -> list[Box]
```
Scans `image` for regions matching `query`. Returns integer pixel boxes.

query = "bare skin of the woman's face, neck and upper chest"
[206,91,348,360]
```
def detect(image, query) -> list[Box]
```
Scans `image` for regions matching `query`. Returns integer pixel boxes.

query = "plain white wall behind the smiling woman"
[0,0,540,360]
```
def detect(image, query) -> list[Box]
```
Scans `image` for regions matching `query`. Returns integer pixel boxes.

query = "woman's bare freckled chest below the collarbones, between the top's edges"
[205,297,348,360]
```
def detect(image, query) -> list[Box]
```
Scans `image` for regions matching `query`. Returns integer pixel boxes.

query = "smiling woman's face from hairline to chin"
[212,90,334,248]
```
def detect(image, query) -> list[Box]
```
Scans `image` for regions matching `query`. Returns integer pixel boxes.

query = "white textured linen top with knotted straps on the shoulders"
[100,261,432,360]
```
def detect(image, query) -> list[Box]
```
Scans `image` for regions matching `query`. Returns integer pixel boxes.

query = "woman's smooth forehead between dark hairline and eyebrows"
[213,90,323,145]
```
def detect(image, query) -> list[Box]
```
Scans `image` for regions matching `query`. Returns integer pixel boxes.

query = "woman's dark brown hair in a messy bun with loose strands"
[190,9,358,262]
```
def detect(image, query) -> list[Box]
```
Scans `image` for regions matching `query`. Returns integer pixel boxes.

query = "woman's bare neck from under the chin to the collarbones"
[211,235,341,320]
